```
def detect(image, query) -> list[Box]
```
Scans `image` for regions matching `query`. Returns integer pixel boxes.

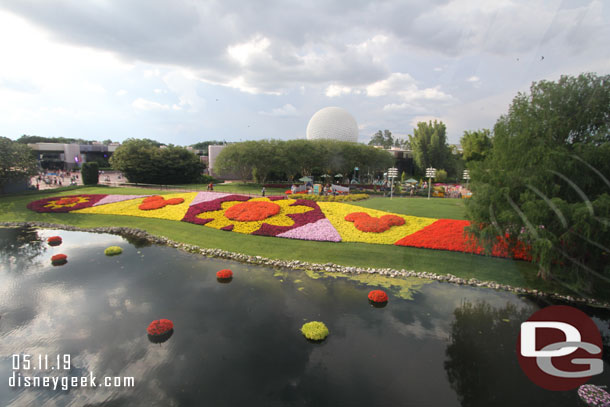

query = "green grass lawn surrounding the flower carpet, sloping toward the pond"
[0,187,563,292]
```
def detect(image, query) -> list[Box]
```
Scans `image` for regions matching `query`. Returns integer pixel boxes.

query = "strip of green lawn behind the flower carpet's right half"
[350,197,466,219]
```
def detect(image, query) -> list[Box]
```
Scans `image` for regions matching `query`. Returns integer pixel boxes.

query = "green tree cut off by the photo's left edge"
[0,137,38,189]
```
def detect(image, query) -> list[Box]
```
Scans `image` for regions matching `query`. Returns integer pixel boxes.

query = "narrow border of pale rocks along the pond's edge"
[0,222,610,308]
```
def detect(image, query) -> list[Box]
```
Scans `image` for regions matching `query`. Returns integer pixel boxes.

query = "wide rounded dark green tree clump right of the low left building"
[110,139,204,184]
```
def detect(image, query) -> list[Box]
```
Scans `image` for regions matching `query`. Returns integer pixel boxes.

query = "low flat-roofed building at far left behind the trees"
[28,143,120,170]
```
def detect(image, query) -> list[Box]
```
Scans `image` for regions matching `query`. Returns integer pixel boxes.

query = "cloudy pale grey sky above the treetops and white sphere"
[0,0,610,145]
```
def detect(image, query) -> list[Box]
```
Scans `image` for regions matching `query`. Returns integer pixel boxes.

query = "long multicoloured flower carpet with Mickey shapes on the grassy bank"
[27,192,530,260]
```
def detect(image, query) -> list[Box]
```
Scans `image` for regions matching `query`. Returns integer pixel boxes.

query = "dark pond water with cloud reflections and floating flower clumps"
[0,228,610,407]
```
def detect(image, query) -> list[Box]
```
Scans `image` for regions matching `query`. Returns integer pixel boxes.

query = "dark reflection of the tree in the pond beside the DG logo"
[445,301,610,407]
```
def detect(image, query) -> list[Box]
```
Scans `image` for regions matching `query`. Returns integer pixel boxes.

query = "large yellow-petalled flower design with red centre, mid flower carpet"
[197,198,313,234]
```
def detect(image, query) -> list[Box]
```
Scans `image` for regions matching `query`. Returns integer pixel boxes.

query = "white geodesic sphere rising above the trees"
[307,107,358,143]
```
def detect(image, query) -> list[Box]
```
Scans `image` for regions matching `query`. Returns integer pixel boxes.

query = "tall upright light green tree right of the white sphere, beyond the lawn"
[409,120,452,174]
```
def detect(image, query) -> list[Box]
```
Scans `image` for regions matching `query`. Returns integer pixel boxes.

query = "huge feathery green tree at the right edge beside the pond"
[467,74,610,295]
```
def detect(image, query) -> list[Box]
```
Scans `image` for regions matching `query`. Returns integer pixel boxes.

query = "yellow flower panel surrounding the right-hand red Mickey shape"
[318,202,437,244]
